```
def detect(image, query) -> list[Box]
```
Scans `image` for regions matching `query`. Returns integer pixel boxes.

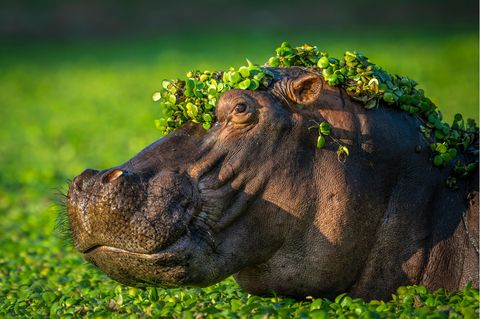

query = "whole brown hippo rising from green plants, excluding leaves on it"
[68,68,479,299]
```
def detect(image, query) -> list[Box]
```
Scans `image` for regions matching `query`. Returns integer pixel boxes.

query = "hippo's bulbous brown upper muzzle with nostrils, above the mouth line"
[67,168,198,254]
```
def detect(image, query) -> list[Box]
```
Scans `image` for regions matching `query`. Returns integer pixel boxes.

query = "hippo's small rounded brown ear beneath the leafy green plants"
[287,73,323,104]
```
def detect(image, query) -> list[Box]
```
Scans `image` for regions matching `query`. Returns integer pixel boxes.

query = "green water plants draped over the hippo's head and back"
[153,42,478,188]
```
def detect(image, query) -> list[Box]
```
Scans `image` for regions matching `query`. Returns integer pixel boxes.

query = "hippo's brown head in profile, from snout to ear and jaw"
[67,68,338,286]
